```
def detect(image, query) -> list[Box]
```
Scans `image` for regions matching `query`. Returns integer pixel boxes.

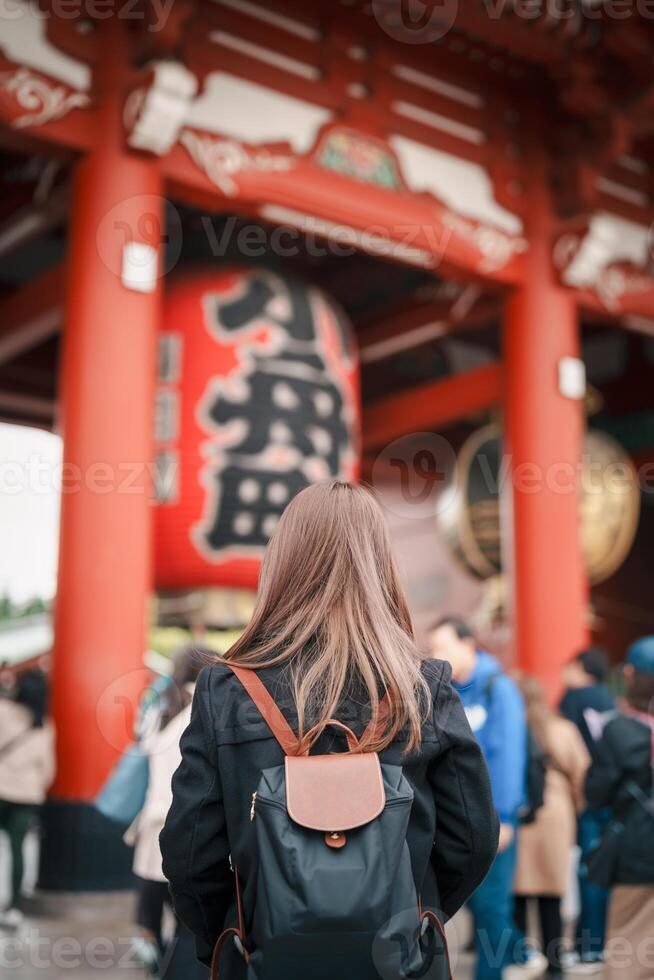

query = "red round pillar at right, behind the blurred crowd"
[504,142,588,698]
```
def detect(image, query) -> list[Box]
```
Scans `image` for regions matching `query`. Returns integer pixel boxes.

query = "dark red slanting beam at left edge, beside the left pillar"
[0,264,64,364]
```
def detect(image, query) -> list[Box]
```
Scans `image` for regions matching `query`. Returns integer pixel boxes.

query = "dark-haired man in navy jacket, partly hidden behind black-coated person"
[559,647,615,970]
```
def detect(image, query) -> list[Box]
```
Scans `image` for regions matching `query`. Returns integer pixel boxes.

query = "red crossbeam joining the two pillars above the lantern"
[161,142,526,285]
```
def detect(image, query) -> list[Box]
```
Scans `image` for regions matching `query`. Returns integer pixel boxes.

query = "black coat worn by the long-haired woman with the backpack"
[160,661,498,968]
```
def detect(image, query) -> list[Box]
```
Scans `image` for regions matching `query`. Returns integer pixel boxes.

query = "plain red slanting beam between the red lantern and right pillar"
[363,363,502,453]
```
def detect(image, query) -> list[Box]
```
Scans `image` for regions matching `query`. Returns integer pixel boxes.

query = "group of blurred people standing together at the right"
[430,617,654,980]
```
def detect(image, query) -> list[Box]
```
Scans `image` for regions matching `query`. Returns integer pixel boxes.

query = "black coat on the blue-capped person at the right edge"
[586,715,654,885]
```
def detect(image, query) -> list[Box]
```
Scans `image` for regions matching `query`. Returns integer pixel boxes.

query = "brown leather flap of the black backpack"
[286,752,386,831]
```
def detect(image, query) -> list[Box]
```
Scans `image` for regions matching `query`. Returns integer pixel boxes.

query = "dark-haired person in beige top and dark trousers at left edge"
[0,670,55,927]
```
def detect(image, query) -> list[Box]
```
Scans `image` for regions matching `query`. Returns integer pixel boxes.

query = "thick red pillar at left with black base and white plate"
[41,30,163,890]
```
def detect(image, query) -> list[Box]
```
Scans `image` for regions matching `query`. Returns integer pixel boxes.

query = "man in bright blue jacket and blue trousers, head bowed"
[429,616,547,980]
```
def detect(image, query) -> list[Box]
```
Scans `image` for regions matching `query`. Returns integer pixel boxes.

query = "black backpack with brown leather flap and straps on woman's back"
[212,664,452,980]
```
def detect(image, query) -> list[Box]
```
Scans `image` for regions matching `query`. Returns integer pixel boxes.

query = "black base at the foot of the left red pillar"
[38,800,134,892]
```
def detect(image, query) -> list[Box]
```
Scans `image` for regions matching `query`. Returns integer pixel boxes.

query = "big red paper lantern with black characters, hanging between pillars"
[155,269,360,588]
